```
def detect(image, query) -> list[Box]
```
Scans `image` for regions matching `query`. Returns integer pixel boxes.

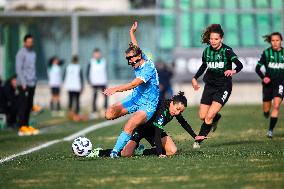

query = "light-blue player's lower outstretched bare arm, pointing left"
[103,78,144,96]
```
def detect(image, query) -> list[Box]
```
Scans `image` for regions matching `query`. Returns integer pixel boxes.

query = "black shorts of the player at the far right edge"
[262,81,284,102]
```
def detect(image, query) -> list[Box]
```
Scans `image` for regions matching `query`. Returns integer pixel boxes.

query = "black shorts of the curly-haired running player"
[201,82,232,106]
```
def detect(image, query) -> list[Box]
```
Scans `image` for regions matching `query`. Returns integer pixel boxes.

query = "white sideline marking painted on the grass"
[0,116,128,164]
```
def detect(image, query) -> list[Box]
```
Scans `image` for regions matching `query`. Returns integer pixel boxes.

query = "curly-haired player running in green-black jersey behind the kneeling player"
[192,24,243,148]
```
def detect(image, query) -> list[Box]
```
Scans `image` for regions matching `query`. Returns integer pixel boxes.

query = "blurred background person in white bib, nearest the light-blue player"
[87,48,108,118]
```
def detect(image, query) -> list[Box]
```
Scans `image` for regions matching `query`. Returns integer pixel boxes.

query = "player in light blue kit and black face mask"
[104,22,159,158]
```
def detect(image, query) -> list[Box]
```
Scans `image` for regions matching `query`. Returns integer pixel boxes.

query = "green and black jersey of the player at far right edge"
[256,47,284,80]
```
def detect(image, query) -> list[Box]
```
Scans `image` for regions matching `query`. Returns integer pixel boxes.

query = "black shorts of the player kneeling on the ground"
[130,125,168,147]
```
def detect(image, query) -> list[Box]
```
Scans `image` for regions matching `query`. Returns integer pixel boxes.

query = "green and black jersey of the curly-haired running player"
[194,44,243,85]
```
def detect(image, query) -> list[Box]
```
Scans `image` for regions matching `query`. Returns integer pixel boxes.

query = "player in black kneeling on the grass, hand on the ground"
[87,92,205,158]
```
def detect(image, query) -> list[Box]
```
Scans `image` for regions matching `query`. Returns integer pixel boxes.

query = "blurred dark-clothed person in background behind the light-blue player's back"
[157,61,173,100]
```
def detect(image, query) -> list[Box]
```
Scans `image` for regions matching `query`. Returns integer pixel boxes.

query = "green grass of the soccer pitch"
[0,106,284,189]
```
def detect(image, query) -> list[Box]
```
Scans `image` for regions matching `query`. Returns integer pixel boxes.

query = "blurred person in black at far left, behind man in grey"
[4,75,19,128]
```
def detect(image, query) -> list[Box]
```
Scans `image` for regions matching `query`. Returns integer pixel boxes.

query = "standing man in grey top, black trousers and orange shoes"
[16,34,39,136]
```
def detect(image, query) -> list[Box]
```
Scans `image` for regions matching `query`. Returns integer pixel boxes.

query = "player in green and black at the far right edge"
[255,32,284,138]
